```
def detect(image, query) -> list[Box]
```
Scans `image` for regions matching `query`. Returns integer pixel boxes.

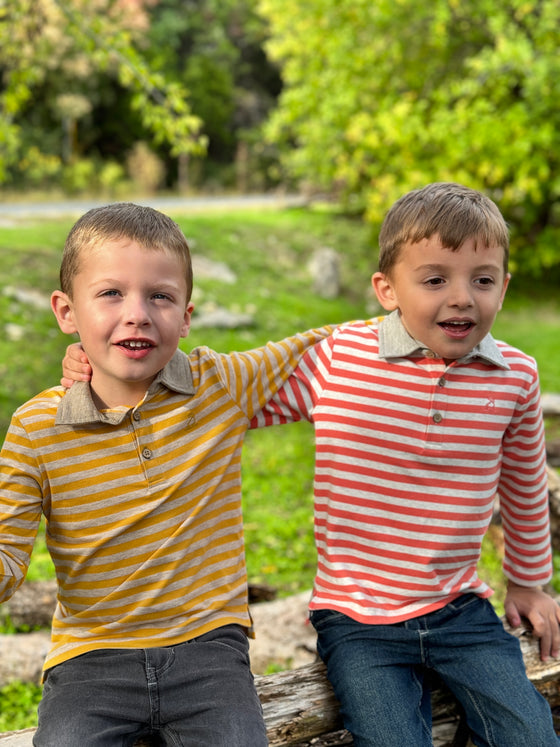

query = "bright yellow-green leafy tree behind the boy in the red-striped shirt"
[259,0,560,274]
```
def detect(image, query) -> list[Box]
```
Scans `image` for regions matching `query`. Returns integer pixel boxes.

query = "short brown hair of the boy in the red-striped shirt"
[379,182,509,274]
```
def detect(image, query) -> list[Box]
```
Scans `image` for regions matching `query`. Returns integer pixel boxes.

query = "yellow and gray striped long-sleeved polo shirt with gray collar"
[0,328,329,669]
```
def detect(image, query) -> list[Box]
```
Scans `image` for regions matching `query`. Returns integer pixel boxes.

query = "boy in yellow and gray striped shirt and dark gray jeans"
[0,203,328,747]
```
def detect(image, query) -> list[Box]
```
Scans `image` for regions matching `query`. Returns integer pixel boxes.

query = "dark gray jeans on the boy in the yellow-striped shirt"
[33,625,268,747]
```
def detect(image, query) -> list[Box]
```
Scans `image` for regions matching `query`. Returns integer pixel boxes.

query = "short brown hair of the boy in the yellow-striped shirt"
[60,202,193,302]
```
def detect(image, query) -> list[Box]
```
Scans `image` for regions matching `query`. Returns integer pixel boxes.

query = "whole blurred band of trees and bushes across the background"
[0,0,560,275]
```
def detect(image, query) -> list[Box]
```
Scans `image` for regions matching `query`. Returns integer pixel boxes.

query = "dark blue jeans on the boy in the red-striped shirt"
[311,594,560,747]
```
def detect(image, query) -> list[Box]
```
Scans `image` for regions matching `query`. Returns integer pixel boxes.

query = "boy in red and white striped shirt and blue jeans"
[257,183,560,747]
